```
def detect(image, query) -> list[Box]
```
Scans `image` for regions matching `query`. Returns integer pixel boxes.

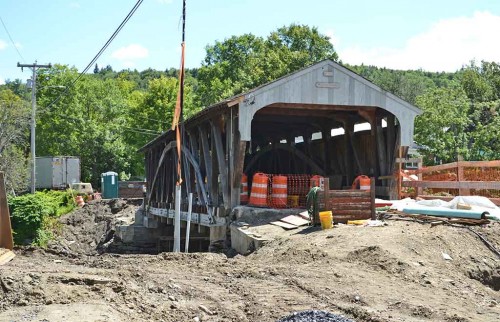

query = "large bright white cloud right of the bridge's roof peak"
[339,11,500,71]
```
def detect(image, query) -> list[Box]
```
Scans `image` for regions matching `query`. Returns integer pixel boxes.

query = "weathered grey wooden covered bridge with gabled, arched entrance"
[142,60,421,247]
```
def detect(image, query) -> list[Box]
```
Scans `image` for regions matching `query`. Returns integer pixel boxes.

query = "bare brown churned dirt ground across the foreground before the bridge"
[0,203,500,322]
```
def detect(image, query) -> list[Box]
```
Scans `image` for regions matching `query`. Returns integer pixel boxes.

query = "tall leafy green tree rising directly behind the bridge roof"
[197,24,338,106]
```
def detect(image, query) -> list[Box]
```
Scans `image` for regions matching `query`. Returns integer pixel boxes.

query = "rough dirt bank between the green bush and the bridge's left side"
[48,199,140,256]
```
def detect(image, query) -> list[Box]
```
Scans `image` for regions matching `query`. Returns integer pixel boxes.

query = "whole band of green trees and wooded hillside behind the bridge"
[0,24,500,191]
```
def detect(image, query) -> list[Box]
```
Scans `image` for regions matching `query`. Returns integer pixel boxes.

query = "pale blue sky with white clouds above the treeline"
[0,0,500,84]
